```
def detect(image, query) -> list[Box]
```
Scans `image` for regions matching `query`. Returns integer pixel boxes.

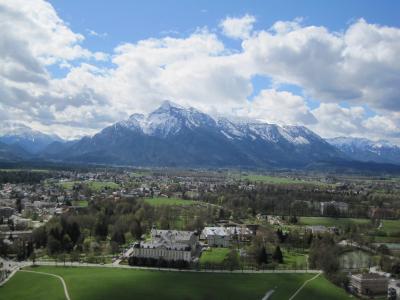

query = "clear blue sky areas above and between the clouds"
[50,0,400,107]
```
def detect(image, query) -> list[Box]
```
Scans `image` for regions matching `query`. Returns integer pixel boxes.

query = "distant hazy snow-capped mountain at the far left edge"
[0,122,61,153]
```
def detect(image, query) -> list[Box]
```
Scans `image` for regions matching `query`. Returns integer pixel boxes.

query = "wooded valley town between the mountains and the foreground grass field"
[0,168,400,299]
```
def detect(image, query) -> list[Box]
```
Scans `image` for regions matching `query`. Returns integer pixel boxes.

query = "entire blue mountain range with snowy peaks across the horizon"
[0,101,400,168]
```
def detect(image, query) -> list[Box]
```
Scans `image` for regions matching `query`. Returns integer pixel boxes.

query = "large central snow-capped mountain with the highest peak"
[50,101,341,167]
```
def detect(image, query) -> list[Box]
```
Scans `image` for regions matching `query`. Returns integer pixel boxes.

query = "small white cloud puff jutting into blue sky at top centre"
[219,15,256,39]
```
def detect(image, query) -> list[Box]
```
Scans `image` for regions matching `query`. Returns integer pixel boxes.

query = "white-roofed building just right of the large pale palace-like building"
[201,226,253,247]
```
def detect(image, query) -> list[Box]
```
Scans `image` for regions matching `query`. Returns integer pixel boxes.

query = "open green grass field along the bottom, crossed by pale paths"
[0,267,348,300]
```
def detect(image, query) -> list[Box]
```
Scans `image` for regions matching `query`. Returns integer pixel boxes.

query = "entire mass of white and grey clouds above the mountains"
[0,0,400,144]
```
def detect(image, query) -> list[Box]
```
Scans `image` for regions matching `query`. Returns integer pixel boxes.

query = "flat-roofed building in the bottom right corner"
[350,273,389,295]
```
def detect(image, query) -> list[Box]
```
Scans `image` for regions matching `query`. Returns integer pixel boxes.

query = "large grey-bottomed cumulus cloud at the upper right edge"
[243,19,400,110]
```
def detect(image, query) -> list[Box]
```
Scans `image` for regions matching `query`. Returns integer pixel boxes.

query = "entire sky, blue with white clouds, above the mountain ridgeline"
[0,0,400,144]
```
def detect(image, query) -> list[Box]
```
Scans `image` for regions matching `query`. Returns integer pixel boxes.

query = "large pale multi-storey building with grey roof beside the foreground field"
[132,229,198,262]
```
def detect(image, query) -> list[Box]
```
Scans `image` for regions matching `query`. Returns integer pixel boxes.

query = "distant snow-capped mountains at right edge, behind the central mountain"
[327,137,400,164]
